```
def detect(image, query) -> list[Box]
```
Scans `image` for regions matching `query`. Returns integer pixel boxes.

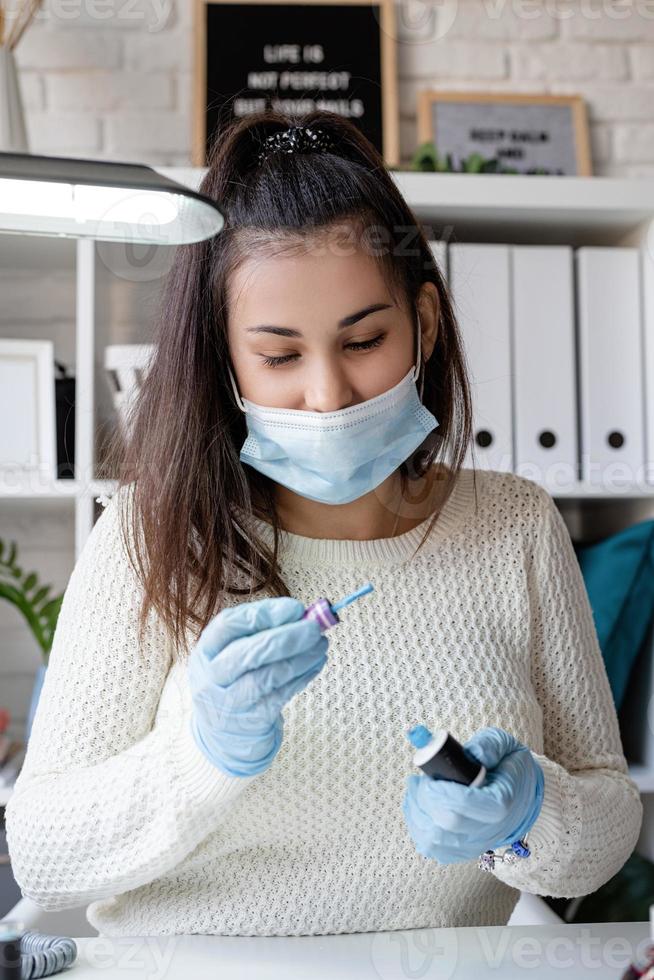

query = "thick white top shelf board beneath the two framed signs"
[154,167,654,246]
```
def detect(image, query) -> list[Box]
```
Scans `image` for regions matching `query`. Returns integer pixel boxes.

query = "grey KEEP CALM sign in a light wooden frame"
[418,90,592,176]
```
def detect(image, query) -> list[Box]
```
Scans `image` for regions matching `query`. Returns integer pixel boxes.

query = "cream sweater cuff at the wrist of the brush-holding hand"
[171,716,259,810]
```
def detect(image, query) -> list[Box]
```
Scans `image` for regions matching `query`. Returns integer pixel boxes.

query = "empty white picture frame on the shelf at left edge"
[0,339,57,490]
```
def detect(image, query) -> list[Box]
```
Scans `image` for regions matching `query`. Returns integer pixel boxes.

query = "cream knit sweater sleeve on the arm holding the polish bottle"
[493,487,643,898]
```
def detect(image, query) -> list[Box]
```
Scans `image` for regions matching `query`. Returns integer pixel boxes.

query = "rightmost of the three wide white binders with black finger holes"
[576,245,645,490]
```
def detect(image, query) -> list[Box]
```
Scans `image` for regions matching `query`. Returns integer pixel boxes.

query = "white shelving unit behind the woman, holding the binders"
[0,167,654,536]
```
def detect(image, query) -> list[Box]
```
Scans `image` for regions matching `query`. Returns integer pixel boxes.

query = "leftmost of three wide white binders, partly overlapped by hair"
[448,243,513,472]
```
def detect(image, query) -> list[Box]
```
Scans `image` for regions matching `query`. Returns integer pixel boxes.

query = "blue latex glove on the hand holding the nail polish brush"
[188,596,329,776]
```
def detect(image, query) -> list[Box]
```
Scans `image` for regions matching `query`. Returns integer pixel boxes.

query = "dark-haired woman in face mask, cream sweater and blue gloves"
[7,112,642,936]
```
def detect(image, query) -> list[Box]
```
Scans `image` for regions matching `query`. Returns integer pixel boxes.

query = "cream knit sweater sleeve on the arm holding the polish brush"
[5,487,256,909]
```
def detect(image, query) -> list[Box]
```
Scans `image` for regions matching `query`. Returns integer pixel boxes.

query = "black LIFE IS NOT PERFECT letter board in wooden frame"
[193,0,399,167]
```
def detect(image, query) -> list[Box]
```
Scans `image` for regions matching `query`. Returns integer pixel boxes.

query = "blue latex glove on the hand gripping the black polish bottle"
[402,728,544,864]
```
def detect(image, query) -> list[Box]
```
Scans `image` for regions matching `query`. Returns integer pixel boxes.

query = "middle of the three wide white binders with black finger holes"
[511,245,579,490]
